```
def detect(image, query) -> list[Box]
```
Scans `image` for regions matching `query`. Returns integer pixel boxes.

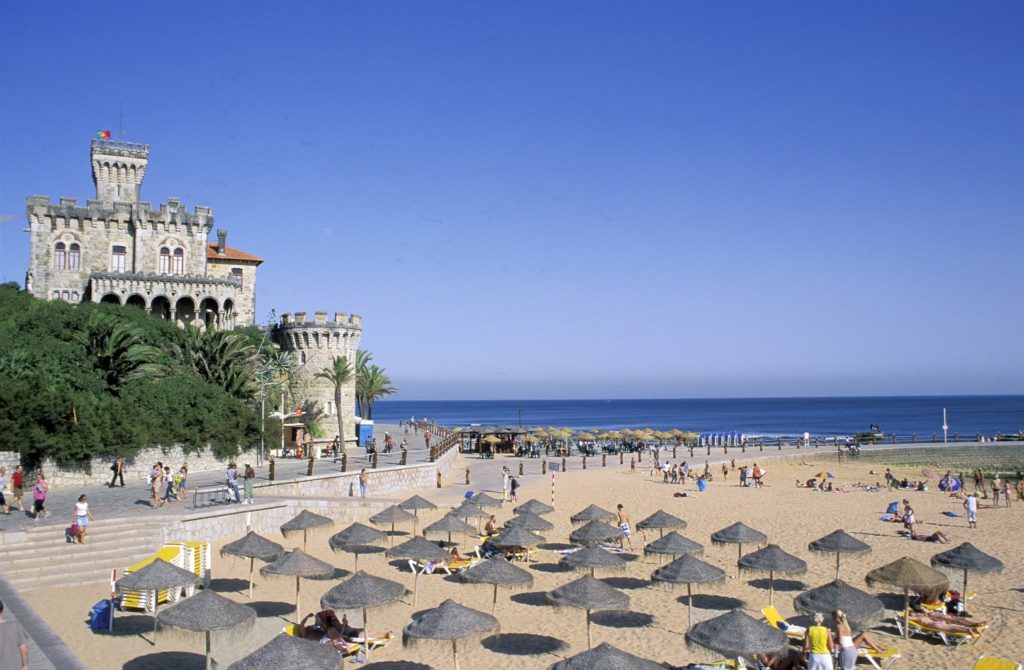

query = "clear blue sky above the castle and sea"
[0,0,1024,400]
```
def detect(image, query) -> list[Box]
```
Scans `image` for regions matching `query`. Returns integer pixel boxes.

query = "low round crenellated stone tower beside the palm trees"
[270,311,362,445]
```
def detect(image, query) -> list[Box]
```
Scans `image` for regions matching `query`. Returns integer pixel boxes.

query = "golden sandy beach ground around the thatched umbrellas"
[26,451,1024,670]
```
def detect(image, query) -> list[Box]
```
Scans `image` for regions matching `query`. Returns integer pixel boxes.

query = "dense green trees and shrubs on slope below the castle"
[0,285,259,465]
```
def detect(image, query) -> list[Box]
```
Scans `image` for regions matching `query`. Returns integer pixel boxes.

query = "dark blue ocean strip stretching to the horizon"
[374,395,1024,441]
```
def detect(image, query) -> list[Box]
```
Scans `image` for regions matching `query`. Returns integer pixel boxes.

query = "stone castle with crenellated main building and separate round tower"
[25,139,362,442]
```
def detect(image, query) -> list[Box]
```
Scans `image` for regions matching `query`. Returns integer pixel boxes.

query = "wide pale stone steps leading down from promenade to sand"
[0,518,167,591]
